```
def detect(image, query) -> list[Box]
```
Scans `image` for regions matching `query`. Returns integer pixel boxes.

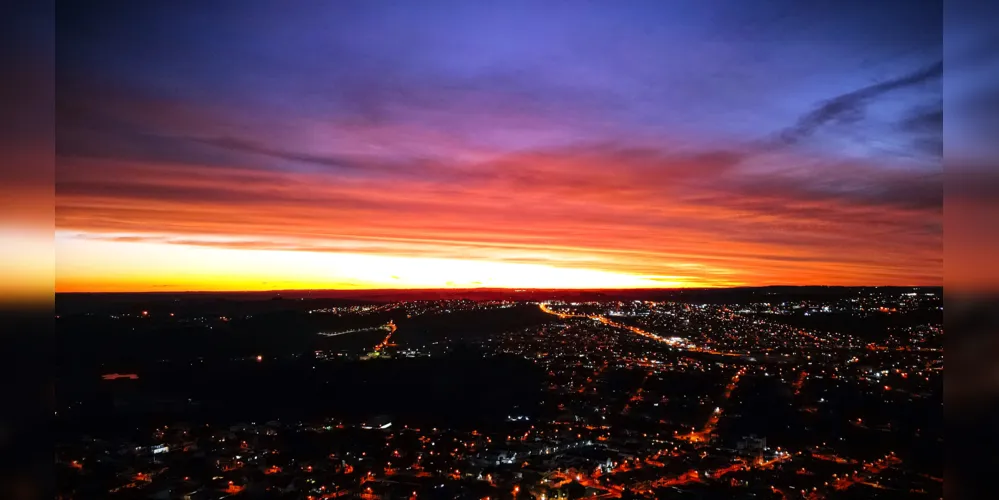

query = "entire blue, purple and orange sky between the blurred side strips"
[55,0,950,292]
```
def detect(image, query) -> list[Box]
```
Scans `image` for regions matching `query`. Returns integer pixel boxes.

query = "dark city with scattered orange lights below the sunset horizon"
[56,288,943,499]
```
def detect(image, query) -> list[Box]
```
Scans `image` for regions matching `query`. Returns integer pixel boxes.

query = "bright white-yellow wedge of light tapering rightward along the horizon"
[56,234,703,292]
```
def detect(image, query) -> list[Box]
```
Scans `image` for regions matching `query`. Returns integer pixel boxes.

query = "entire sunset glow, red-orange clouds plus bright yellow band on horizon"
[55,146,942,292]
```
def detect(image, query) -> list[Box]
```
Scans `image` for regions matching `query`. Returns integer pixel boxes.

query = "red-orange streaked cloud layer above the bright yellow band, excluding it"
[56,135,940,290]
